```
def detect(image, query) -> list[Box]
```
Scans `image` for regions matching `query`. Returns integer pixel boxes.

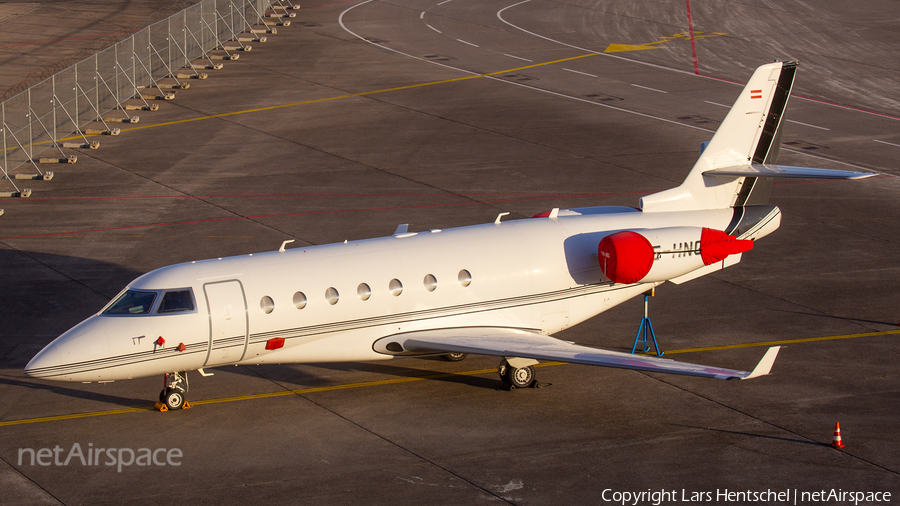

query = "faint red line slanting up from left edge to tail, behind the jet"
[0,192,647,241]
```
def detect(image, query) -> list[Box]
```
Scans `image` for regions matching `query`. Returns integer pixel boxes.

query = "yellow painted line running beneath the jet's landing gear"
[0,330,900,427]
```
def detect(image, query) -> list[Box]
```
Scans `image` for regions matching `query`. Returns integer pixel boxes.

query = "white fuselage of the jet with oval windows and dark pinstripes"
[26,207,778,381]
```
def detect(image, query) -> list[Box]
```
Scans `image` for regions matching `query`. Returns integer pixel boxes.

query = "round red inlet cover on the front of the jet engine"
[597,230,653,283]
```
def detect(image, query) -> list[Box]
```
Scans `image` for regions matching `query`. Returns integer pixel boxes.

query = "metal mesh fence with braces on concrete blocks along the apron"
[0,0,288,197]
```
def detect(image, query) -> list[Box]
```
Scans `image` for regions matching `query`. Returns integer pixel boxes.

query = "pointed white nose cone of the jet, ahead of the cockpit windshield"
[25,317,109,381]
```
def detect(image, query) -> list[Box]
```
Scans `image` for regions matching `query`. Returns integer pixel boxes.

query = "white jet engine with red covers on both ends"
[597,227,753,283]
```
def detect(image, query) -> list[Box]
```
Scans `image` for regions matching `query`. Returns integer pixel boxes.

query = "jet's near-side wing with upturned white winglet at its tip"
[376,327,780,379]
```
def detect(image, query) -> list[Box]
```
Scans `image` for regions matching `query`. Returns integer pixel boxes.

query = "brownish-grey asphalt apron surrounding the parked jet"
[0,0,900,505]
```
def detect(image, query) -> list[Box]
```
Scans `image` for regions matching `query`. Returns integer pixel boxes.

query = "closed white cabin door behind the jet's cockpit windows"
[203,280,247,367]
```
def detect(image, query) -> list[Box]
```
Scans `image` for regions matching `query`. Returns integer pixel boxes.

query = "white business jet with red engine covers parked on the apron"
[25,62,874,409]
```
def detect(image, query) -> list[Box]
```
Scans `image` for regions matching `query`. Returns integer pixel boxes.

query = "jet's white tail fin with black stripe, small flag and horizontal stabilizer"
[641,61,875,212]
